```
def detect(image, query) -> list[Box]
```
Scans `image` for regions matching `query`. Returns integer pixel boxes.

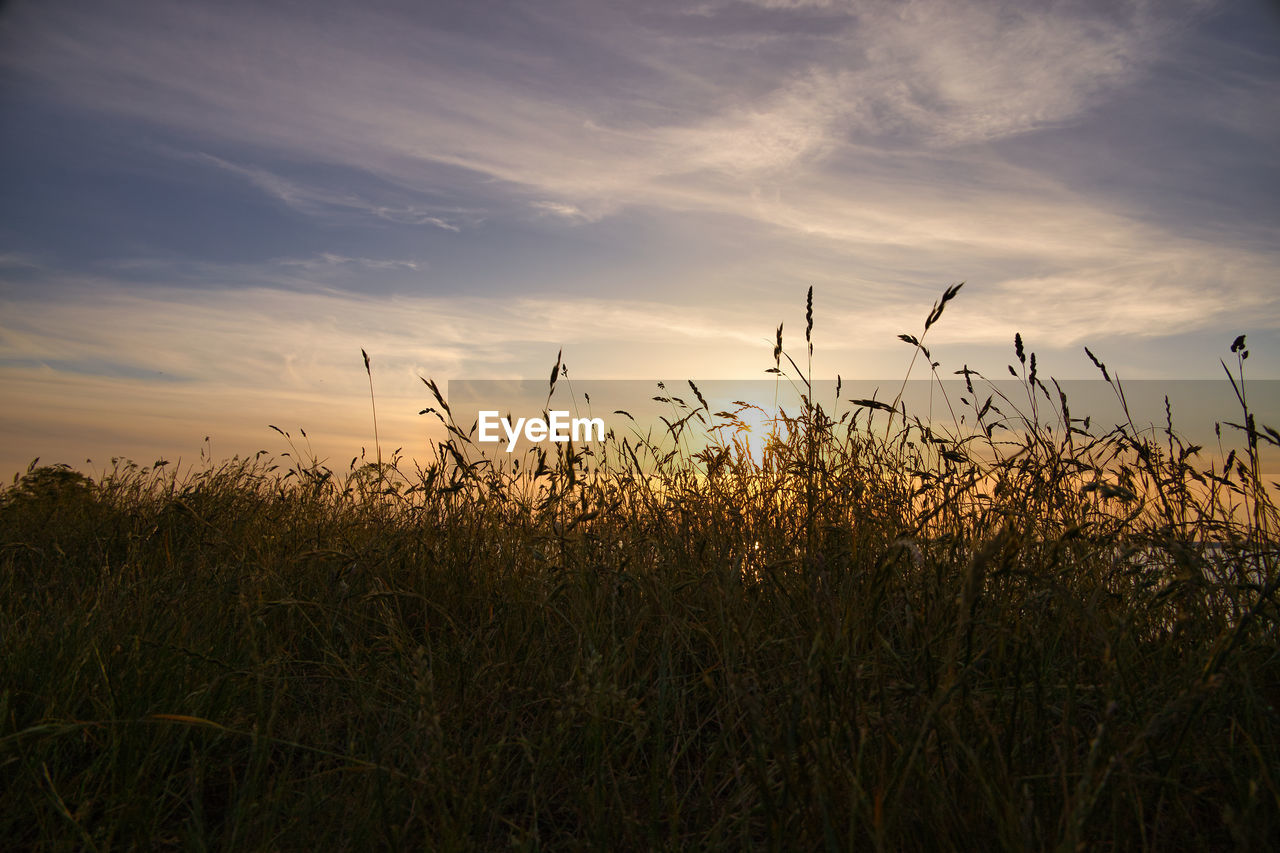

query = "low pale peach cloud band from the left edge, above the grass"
[0,268,756,392]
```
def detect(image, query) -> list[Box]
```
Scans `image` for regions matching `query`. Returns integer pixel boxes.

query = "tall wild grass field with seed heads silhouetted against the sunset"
[0,288,1280,850]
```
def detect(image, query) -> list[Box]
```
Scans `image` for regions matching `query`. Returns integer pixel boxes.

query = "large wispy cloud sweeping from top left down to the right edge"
[9,0,1275,318]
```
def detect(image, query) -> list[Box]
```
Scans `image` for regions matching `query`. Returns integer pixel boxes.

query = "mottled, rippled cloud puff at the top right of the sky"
[847,3,1161,146]
